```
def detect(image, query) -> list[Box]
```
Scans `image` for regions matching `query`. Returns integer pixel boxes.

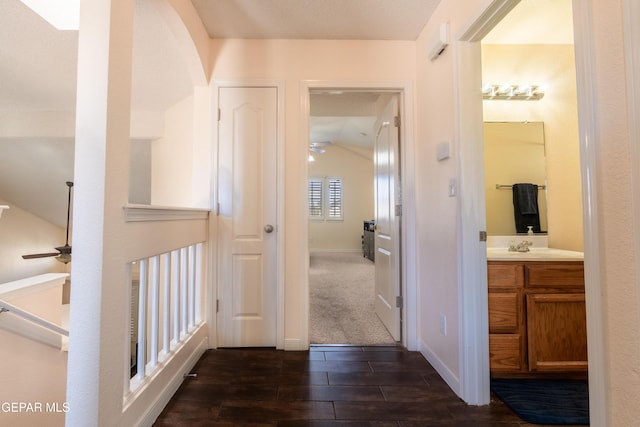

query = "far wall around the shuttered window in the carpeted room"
[309,145,374,251]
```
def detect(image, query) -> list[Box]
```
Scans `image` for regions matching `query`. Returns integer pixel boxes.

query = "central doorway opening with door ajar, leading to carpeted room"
[307,88,402,345]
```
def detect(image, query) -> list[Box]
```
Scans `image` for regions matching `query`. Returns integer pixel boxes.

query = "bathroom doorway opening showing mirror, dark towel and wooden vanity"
[481,0,587,384]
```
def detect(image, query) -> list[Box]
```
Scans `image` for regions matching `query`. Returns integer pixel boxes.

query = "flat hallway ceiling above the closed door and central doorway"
[191,0,440,40]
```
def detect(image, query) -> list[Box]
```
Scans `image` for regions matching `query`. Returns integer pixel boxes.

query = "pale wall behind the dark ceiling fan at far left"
[0,199,71,283]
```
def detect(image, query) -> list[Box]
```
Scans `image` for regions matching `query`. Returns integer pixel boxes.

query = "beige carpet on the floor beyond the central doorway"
[309,252,395,344]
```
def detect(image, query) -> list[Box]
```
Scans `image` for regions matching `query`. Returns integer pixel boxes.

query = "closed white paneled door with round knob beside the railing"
[217,87,278,347]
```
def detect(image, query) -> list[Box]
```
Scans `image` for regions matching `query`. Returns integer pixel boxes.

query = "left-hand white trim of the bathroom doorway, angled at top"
[455,0,520,405]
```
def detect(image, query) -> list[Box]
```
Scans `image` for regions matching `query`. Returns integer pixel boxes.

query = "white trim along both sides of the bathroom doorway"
[456,0,607,418]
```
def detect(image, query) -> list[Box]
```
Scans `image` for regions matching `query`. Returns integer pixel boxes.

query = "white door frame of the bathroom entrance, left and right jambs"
[456,0,606,414]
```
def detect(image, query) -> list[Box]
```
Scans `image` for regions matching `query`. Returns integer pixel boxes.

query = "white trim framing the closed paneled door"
[208,79,285,349]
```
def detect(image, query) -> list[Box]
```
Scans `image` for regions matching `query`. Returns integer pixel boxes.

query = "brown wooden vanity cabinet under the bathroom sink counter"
[488,260,587,377]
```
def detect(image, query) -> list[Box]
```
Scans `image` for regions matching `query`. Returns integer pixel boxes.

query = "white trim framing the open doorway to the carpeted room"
[299,80,418,350]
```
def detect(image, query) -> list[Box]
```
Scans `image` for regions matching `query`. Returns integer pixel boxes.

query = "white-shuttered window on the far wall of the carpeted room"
[309,177,343,221]
